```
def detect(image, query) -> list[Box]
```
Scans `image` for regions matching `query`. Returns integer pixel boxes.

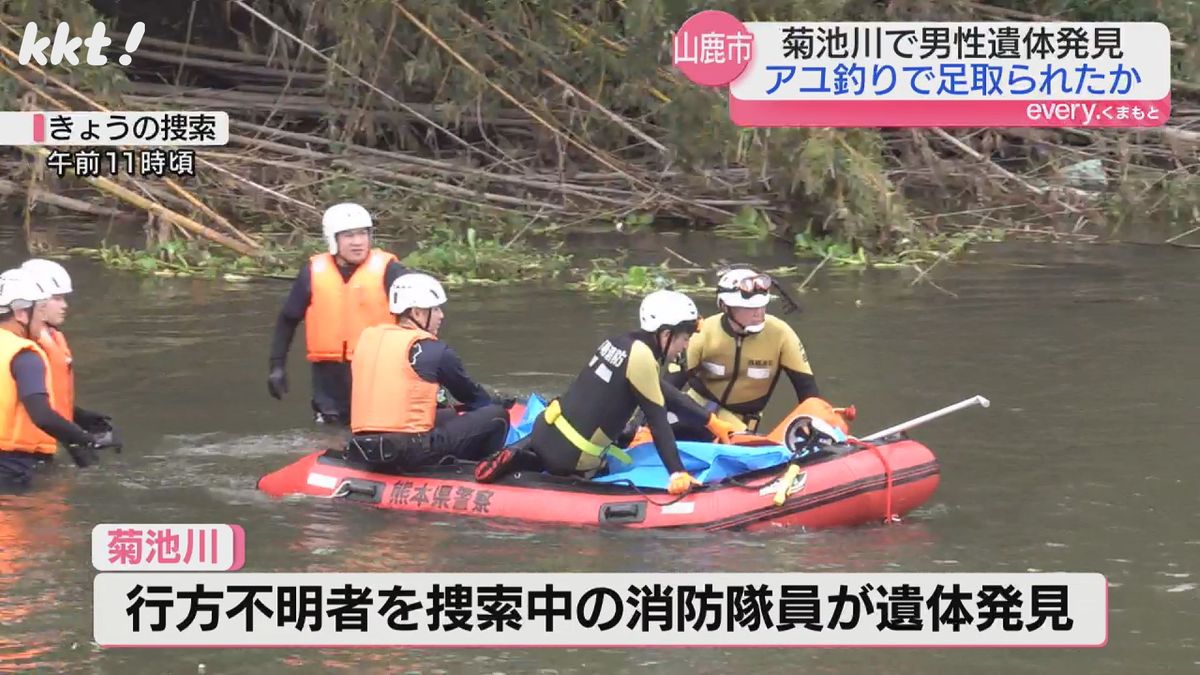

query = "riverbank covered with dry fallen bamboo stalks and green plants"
[0,0,1200,288]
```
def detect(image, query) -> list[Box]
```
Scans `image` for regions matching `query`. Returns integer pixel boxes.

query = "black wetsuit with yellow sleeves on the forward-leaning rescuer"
[528,331,708,476]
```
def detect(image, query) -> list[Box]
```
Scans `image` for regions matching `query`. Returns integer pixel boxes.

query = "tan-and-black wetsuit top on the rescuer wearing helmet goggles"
[667,313,820,425]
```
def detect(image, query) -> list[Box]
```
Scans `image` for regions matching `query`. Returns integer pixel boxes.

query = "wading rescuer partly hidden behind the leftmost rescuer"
[20,258,116,437]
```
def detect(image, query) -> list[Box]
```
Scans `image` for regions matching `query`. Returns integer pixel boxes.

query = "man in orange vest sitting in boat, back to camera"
[346,273,509,472]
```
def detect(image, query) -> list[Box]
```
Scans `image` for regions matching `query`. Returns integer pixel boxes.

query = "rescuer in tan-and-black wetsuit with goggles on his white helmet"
[667,269,820,441]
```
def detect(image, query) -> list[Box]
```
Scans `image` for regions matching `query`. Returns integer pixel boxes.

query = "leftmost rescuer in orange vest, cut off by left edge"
[0,269,120,488]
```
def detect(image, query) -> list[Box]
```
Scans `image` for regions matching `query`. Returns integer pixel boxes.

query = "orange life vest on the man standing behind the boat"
[304,249,396,362]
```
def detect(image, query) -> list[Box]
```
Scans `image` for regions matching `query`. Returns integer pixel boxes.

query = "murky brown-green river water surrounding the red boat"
[0,219,1200,675]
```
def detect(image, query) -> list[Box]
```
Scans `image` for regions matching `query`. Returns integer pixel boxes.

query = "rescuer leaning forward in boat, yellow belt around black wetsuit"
[475,285,731,495]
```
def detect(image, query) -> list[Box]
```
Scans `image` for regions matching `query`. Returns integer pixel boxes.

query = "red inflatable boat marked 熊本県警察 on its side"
[258,398,940,530]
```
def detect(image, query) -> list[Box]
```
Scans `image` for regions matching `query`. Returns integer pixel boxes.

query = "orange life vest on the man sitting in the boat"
[350,324,438,434]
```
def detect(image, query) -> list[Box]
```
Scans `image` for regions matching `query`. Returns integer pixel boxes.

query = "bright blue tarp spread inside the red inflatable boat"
[505,394,792,490]
